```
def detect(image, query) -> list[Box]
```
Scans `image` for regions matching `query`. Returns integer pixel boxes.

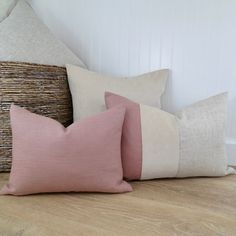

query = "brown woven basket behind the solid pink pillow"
[0,62,73,172]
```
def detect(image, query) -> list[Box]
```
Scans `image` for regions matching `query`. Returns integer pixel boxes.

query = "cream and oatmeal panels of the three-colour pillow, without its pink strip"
[140,93,235,179]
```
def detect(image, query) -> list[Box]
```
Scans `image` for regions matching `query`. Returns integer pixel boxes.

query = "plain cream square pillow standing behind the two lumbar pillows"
[66,65,168,120]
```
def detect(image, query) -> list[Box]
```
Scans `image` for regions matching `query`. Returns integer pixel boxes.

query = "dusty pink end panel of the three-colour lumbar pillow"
[105,92,142,180]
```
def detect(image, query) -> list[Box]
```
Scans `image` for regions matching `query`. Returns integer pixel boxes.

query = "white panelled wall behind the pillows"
[28,0,236,163]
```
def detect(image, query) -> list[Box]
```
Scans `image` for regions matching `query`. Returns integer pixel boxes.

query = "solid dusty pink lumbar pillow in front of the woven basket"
[1,105,132,195]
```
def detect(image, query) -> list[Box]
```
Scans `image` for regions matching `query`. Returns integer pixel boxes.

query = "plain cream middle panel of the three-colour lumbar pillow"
[140,105,179,180]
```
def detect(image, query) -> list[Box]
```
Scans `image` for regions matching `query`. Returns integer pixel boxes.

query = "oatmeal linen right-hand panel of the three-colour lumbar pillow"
[176,93,233,177]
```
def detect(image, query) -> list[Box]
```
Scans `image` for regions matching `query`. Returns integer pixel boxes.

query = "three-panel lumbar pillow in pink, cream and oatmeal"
[105,92,234,180]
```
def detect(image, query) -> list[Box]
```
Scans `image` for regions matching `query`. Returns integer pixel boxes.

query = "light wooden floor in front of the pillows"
[0,174,236,236]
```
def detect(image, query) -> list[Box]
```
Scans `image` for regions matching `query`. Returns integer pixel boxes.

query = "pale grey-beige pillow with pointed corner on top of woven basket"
[0,0,84,66]
